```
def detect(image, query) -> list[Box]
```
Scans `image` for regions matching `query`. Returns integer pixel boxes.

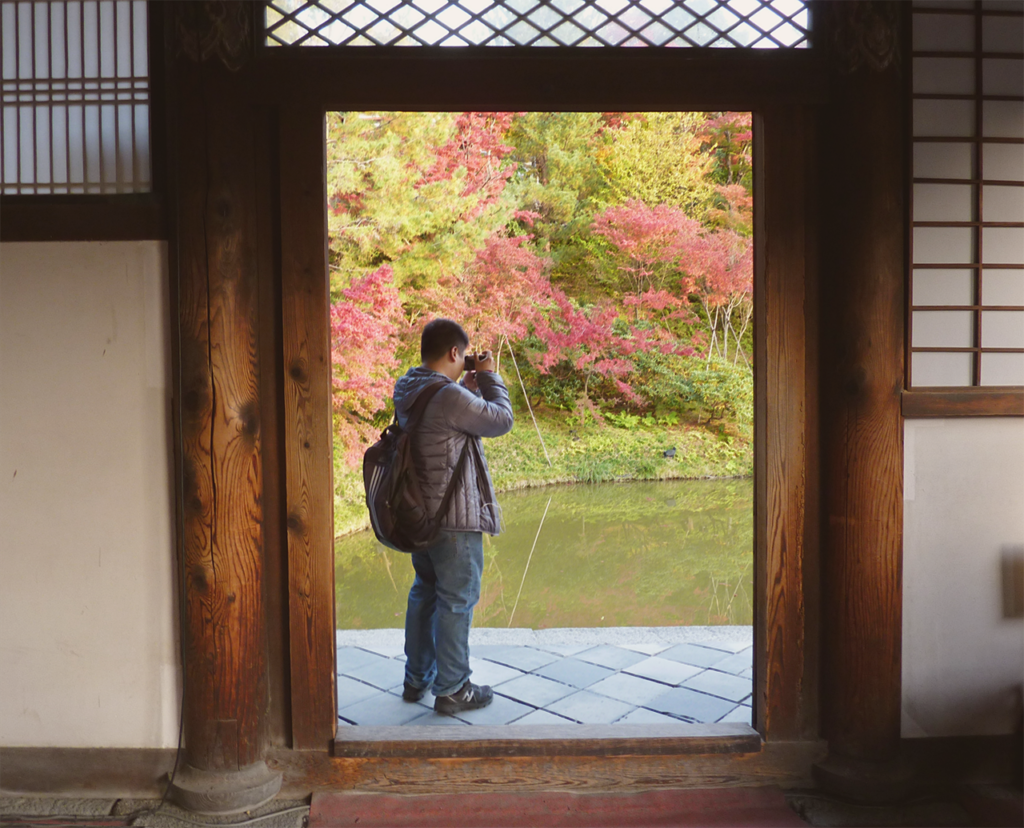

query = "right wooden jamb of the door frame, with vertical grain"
[755,107,812,740]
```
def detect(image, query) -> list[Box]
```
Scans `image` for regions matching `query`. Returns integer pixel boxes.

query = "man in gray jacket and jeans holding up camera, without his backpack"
[394,319,512,715]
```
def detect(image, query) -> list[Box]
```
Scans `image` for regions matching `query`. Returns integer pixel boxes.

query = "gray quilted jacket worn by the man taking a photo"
[394,365,512,534]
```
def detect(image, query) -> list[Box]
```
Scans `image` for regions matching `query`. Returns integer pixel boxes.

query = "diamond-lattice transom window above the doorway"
[266,0,810,49]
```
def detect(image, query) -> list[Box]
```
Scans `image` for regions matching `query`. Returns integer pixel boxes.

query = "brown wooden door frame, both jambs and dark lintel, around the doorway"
[260,49,826,750]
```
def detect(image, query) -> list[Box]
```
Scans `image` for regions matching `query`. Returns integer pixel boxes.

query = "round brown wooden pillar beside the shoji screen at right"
[816,0,907,799]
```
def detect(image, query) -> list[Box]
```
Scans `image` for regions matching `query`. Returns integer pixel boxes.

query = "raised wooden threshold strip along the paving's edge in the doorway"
[334,723,761,758]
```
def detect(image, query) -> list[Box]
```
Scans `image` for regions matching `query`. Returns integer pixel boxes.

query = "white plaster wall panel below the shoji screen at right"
[903,418,1024,737]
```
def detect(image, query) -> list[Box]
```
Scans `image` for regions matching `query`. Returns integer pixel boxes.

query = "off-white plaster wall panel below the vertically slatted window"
[0,242,180,747]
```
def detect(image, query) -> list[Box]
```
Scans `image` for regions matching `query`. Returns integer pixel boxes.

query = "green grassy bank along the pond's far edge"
[334,411,754,536]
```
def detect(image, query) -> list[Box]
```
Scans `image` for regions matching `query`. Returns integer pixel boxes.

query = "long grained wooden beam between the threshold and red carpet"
[267,742,824,796]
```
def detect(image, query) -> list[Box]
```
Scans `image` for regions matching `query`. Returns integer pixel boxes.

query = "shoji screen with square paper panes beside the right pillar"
[908,0,1024,388]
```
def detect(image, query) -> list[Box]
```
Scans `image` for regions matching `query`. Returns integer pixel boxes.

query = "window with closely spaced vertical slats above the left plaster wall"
[0,0,151,195]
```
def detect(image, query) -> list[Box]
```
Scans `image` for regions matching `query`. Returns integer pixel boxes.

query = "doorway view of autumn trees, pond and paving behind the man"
[327,112,754,726]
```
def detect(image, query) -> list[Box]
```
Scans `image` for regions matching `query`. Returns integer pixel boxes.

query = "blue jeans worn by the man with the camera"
[406,532,483,696]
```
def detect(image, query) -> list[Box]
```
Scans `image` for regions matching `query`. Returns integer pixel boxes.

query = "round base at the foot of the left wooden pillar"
[171,761,282,815]
